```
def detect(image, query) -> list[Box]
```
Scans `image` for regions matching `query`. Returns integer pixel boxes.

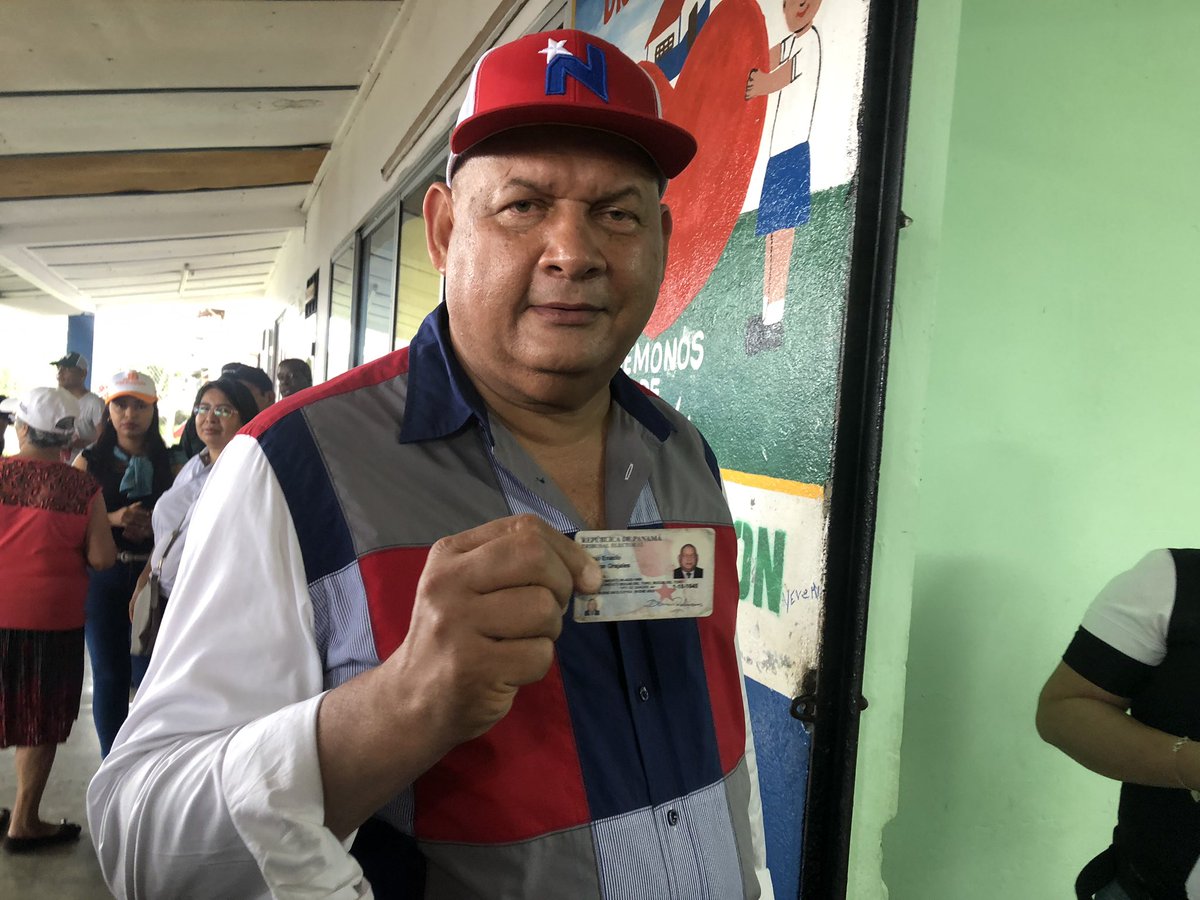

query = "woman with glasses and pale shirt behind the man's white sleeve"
[130,376,258,657]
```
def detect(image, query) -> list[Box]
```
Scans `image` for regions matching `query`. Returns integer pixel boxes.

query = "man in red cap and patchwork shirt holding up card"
[89,30,770,900]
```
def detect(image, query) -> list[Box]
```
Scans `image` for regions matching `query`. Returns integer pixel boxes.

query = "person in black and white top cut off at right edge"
[1037,550,1200,900]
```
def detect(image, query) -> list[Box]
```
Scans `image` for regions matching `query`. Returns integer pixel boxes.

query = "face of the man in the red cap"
[425,127,671,406]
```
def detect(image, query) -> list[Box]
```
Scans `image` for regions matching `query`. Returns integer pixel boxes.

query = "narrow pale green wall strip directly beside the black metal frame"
[846,0,961,900]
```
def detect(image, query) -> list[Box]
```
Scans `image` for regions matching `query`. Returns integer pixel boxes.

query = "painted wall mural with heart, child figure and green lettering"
[574,0,870,898]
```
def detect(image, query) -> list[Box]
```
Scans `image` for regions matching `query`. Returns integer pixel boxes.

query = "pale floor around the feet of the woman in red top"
[0,666,112,900]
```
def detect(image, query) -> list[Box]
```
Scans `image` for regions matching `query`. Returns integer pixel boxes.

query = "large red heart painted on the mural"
[640,0,769,338]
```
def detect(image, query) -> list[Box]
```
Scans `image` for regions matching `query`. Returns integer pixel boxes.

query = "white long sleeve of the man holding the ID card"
[88,437,371,900]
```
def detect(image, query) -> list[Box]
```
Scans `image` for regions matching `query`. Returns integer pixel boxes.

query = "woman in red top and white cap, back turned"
[0,388,116,853]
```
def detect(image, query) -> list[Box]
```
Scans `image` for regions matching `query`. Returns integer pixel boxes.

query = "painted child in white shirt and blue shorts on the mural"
[745,0,822,353]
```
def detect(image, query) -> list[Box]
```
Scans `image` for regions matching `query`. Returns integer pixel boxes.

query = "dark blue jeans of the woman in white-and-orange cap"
[84,563,150,756]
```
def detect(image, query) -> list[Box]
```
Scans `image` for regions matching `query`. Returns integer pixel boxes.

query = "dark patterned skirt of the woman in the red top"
[0,628,83,748]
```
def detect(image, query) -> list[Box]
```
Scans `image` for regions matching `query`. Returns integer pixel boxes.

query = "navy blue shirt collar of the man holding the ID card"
[400,304,674,444]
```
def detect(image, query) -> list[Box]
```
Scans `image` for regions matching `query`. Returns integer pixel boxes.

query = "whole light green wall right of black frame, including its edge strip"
[850,0,1200,900]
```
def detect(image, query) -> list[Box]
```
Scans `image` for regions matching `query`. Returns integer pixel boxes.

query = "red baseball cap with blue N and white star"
[446,29,696,181]
